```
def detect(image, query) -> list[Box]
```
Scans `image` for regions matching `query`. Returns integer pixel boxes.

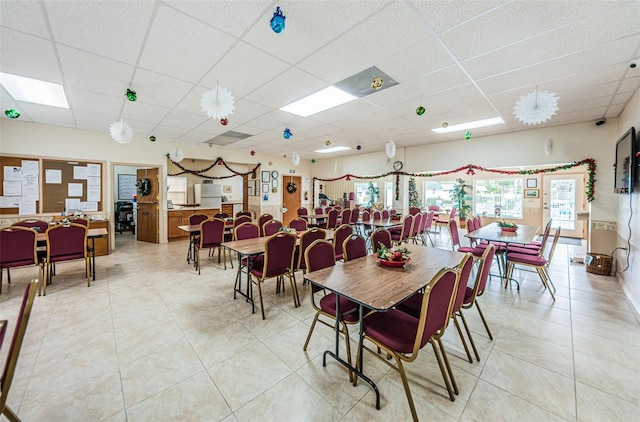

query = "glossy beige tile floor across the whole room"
[0,232,640,422]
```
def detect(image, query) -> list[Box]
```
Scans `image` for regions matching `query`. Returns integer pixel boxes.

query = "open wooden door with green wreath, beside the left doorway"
[136,167,160,243]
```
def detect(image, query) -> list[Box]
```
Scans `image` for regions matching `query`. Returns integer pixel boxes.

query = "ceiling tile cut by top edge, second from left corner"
[43,0,156,64]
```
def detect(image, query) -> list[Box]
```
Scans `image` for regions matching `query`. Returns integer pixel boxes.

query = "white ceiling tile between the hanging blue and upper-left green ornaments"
[140,4,236,83]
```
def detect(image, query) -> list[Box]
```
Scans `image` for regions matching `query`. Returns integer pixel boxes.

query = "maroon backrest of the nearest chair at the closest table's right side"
[413,268,460,354]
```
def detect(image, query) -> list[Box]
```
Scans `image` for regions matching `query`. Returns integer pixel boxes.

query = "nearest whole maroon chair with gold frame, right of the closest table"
[354,269,459,421]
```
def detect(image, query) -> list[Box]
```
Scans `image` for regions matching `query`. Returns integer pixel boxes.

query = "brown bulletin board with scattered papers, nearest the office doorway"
[42,159,104,213]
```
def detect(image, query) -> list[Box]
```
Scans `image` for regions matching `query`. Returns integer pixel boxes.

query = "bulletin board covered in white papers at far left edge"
[0,156,42,215]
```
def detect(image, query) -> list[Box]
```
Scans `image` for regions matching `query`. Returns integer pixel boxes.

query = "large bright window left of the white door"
[473,179,522,218]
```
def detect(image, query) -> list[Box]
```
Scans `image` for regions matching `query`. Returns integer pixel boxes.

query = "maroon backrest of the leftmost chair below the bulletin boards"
[0,226,38,268]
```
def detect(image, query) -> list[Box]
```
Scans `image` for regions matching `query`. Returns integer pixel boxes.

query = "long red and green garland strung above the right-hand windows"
[312,158,596,202]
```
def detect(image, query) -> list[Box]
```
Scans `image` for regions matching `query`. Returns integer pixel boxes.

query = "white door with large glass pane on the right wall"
[542,174,586,239]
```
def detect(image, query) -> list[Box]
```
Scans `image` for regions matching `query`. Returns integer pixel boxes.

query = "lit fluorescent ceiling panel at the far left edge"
[0,72,69,108]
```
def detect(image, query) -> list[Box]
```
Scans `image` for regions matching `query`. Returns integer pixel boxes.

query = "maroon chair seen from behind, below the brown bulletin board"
[42,223,91,296]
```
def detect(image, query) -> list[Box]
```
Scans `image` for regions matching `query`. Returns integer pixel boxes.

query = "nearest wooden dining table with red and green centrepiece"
[304,245,464,409]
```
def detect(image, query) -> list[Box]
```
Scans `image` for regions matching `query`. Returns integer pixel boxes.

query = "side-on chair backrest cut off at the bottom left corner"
[0,280,38,415]
